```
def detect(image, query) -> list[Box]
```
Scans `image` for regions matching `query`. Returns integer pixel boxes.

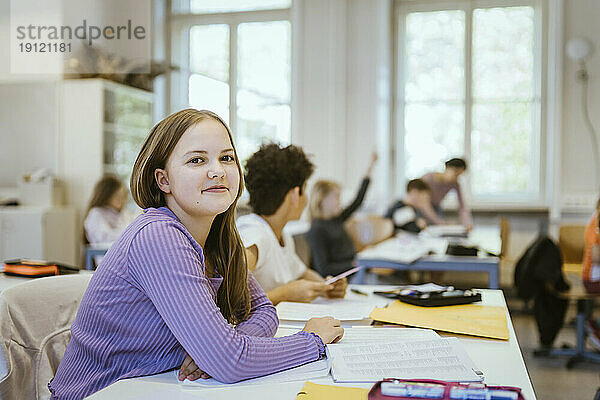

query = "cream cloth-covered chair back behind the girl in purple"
[0,274,91,400]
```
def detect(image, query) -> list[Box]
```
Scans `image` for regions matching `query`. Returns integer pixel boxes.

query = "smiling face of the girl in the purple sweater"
[155,119,240,217]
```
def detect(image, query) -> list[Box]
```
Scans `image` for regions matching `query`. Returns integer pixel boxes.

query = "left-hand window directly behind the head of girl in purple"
[171,0,292,161]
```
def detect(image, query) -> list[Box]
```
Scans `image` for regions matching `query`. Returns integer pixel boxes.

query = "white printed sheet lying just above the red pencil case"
[327,338,483,382]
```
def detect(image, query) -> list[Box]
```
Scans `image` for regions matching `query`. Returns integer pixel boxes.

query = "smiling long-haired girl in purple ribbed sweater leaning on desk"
[48,109,343,399]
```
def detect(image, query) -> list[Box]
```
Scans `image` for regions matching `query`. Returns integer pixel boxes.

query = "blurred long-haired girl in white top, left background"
[83,175,135,244]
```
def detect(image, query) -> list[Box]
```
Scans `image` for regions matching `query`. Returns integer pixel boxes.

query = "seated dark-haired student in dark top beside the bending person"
[385,179,431,233]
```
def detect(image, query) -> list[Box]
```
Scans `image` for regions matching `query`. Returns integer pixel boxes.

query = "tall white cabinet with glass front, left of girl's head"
[59,79,152,222]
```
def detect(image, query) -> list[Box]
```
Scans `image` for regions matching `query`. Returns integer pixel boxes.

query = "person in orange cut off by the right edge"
[581,199,600,350]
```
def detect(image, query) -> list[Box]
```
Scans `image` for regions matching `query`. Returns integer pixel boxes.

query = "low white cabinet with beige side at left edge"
[0,207,78,265]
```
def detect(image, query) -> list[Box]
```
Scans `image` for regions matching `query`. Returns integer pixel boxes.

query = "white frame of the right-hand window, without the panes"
[393,0,549,210]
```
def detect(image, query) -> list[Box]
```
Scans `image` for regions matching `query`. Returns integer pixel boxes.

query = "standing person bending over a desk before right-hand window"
[421,158,473,229]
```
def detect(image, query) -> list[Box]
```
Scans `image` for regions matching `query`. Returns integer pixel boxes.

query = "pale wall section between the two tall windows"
[292,0,391,212]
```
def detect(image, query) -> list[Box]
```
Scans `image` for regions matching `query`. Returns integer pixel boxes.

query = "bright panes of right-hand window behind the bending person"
[397,1,543,203]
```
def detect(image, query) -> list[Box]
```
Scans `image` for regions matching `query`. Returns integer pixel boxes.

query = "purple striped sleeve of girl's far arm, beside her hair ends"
[235,271,279,337]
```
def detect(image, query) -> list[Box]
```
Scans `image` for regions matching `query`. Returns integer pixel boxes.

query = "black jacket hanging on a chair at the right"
[515,235,569,346]
